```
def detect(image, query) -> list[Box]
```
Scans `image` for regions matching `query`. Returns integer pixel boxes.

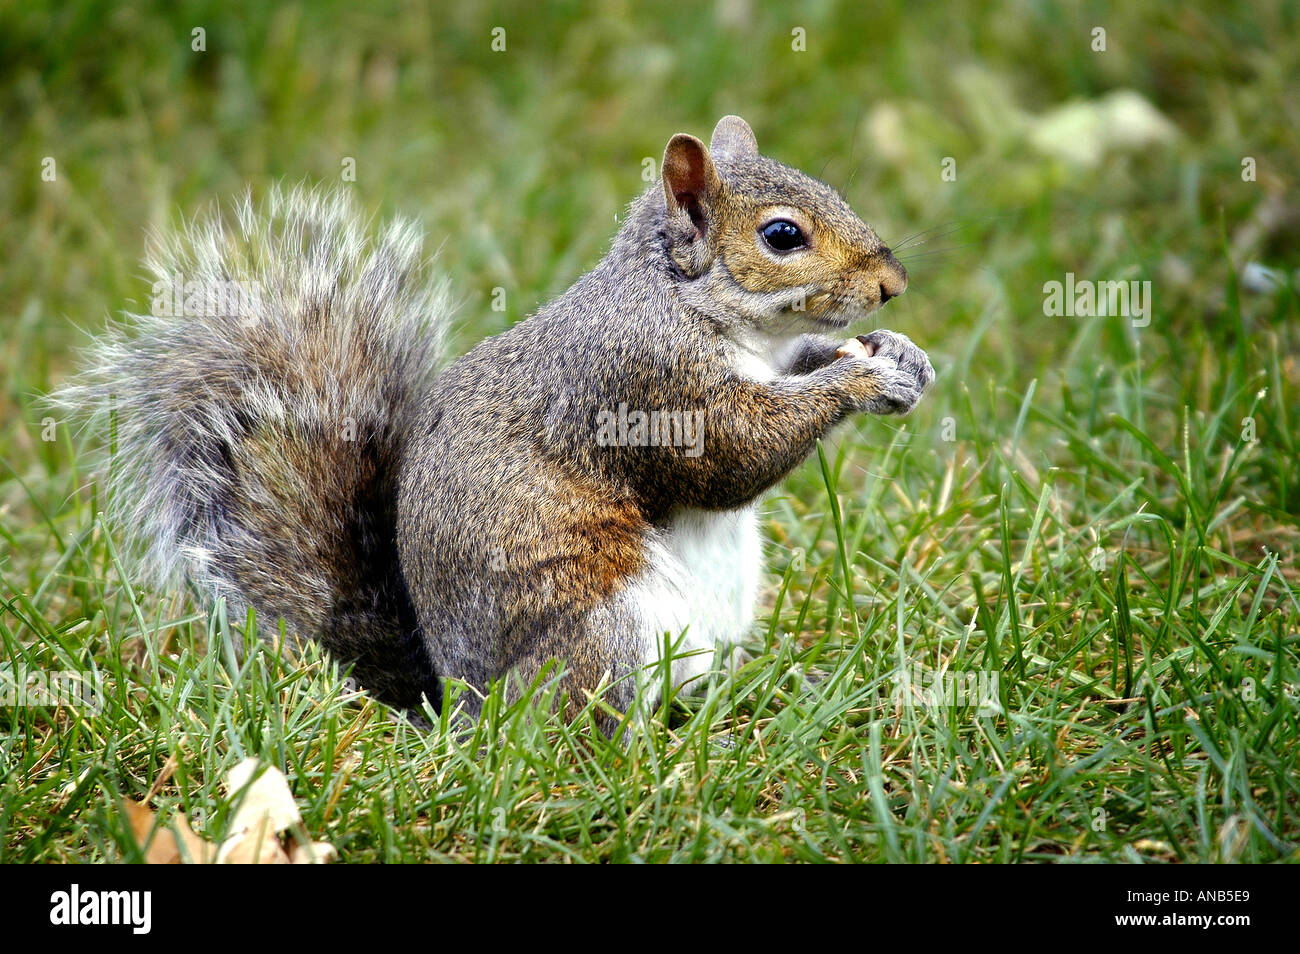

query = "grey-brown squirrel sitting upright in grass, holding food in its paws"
[61,116,935,728]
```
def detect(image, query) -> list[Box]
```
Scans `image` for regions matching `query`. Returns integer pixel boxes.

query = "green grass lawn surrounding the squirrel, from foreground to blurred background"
[0,0,1300,862]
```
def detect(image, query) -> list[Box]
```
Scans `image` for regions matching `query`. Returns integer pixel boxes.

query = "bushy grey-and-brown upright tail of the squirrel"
[59,187,450,706]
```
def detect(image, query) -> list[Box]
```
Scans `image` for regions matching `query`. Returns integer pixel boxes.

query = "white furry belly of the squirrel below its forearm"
[624,507,763,685]
